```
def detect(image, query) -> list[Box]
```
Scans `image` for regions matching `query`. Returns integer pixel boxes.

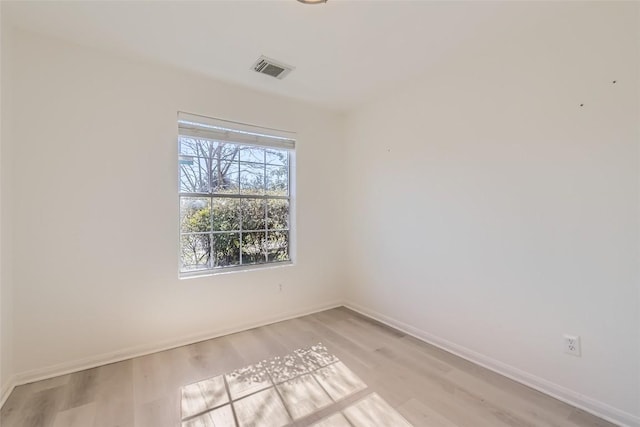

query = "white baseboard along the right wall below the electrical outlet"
[344,302,640,427]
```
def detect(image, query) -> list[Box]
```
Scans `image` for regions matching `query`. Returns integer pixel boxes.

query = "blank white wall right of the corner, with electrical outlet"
[347,2,640,425]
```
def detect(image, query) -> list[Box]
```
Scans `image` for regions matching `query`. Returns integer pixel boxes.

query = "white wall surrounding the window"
[3,32,344,380]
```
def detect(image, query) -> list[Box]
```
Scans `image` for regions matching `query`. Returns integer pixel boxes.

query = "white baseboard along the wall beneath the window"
[6,301,343,402]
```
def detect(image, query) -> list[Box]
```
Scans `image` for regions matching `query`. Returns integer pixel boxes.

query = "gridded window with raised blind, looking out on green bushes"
[178,113,295,275]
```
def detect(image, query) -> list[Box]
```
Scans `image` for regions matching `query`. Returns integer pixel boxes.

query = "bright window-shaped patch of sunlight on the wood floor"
[181,343,411,427]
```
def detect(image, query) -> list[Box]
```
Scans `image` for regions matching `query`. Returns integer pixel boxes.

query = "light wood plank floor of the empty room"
[0,308,612,427]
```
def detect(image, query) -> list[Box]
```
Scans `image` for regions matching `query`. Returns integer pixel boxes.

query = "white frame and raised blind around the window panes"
[177,112,296,279]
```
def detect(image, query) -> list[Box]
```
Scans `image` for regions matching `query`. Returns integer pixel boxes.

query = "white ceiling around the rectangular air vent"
[2,0,552,110]
